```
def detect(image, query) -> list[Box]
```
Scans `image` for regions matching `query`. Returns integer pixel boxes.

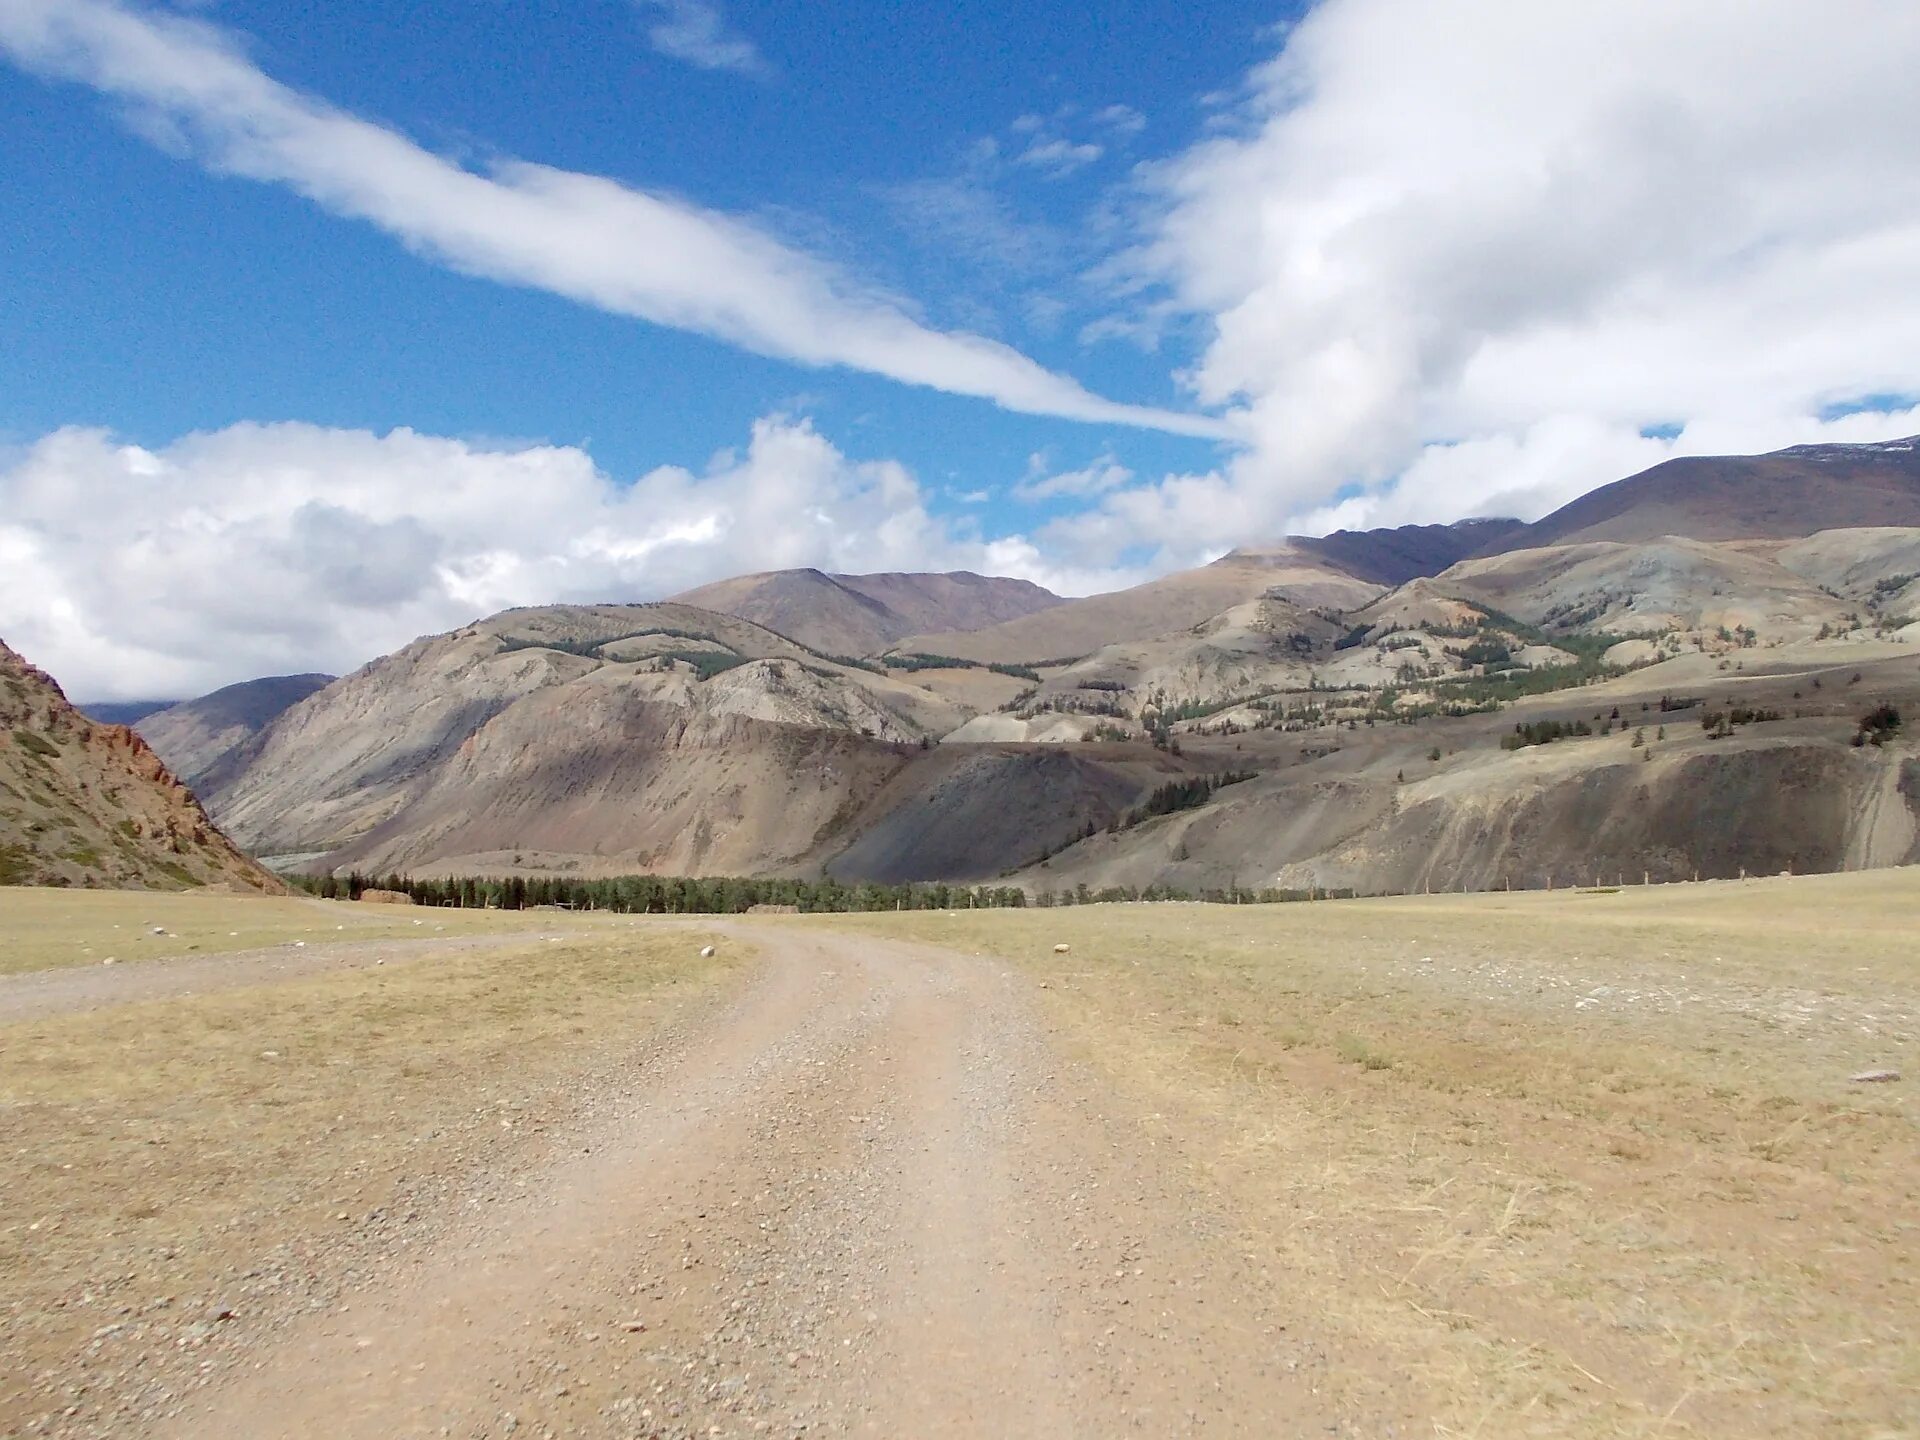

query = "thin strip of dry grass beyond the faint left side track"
[0,887,576,975]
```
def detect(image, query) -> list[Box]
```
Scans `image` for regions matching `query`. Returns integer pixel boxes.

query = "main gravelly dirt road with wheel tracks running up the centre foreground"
[149,927,1336,1440]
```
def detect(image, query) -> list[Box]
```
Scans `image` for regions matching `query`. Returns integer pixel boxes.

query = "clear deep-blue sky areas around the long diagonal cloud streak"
[0,0,1275,506]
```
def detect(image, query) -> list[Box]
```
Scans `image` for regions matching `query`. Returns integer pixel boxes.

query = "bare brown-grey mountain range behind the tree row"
[15,440,1920,891]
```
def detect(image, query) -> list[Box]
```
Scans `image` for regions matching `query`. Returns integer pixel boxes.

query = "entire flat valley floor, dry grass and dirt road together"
[0,870,1920,1438]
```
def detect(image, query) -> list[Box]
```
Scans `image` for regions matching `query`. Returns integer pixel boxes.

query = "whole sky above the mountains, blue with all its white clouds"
[0,0,1920,699]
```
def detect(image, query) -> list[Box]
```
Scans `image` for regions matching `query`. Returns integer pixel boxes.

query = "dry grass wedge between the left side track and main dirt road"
[0,925,741,1434]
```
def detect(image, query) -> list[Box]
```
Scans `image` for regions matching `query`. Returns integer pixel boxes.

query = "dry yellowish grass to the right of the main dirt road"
[829,870,1920,1440]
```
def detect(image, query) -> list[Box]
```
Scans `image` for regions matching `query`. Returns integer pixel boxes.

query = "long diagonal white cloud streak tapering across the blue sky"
[0,0,1225,438]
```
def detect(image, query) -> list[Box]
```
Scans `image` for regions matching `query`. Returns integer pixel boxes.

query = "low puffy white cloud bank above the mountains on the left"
[0,417,1137,699]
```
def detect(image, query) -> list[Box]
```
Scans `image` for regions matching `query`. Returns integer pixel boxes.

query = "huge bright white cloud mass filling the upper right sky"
[1081,0,1920,547]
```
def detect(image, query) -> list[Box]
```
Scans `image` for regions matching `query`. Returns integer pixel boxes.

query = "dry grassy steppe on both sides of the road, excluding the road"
[0,870,1920,1440]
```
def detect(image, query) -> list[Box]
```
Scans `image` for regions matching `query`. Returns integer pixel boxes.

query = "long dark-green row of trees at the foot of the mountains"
[290,872,1352,916]
